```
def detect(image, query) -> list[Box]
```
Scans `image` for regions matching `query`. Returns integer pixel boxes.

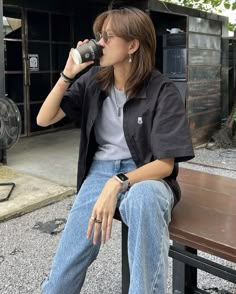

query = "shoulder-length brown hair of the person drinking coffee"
[93,7,156,97]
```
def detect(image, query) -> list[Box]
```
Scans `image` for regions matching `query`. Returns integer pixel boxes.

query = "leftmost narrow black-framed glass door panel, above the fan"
[3,6,27,135]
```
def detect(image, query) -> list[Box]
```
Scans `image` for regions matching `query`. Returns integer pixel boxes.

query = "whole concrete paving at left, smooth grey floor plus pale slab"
[0,130,79,221]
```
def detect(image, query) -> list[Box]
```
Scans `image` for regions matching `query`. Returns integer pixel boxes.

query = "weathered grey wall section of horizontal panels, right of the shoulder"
[187,16,222,143]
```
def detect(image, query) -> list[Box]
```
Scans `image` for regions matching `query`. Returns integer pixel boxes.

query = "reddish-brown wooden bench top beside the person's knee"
[170,168,236,262]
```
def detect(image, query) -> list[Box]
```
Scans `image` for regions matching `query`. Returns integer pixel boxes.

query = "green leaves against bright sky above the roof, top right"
[164,0,236,31]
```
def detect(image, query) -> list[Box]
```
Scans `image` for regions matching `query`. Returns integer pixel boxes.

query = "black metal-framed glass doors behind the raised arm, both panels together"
[3,5,72,136]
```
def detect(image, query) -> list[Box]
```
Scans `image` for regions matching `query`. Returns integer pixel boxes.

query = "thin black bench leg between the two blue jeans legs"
[121,222,130,294]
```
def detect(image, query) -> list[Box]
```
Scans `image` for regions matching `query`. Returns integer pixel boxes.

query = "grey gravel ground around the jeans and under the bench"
[0,148,236,294]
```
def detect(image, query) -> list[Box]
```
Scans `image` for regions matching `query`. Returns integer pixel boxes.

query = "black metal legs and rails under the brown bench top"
[122,229,236,294]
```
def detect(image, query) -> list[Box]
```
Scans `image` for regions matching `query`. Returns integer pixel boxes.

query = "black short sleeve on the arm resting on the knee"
[151,82,194,162]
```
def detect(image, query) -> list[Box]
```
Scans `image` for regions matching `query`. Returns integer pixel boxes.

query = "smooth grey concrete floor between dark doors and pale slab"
[7,129,80,187]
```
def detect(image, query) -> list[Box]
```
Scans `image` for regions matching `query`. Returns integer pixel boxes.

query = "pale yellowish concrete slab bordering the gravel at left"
[0,166,75,222]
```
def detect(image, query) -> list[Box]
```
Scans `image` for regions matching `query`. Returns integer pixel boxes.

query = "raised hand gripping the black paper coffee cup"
[63,39,94,79]
